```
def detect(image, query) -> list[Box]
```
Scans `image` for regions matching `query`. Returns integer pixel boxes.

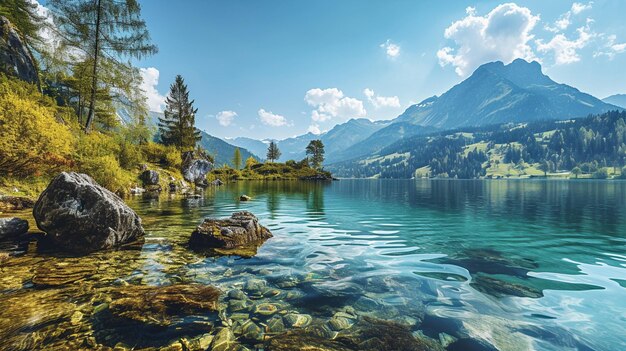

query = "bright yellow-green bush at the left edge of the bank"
[0,74,74,176]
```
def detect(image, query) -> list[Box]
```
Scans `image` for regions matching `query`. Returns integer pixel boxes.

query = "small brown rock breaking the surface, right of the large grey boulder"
[189,211,272,249]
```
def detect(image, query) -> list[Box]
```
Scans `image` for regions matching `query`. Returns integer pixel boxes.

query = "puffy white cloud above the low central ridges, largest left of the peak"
[304,88,367,122]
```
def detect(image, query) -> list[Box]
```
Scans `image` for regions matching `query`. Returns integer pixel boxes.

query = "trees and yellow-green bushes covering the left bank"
[0,0,200,192]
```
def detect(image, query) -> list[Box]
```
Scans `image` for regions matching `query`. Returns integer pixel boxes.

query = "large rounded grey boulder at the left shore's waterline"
[33,172,144,252]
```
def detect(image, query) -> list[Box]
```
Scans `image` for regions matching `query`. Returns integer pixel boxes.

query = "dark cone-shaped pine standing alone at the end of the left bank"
[159,75,202,151]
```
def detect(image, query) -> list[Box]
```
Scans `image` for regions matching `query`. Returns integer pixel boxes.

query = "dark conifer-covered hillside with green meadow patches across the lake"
[331,111,626,178]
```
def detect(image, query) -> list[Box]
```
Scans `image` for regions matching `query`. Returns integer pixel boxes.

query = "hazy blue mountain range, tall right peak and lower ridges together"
[133,59,626,174]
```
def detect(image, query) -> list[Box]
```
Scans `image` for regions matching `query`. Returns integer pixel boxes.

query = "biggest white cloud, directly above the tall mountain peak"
[437,3,539,76]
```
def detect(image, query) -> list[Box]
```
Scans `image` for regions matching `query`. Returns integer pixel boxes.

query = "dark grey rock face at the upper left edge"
[0,16,39,84]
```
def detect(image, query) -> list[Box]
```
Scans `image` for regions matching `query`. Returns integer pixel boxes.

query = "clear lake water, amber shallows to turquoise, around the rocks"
[0,180,626,351]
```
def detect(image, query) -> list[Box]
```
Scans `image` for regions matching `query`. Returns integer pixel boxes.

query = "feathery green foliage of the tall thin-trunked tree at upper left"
[47,0,157,130]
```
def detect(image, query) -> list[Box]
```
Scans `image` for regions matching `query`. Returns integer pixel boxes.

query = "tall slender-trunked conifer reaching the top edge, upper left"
[49,0,157,131]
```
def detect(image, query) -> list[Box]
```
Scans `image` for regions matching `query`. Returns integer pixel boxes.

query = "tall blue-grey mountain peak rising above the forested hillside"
[394,59,618,129]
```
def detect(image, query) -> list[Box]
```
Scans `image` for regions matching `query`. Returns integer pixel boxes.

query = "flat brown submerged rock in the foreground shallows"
[109,284,220,326]
